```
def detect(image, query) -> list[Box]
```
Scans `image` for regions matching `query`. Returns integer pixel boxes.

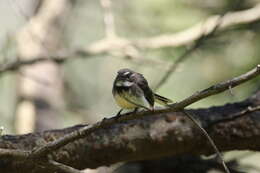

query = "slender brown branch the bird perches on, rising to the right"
[23,65,260,157]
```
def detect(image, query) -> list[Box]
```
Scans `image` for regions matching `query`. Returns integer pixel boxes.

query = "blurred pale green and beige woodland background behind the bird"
[0,0,260,173]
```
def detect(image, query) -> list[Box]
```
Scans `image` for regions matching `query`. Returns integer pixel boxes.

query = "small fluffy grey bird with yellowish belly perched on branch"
[112,69,172,115]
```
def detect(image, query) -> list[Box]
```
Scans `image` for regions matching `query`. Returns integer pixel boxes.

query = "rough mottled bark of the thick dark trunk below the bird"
[0,91,260,173]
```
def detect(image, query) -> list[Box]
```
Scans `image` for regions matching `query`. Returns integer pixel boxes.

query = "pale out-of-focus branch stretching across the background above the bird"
[0,4,260,73]
